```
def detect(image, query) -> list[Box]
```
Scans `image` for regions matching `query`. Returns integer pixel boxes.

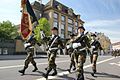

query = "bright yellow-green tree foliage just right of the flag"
[34,18,50,42]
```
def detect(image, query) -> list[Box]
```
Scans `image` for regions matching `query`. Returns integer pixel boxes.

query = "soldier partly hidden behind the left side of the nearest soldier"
[67,33,76,72]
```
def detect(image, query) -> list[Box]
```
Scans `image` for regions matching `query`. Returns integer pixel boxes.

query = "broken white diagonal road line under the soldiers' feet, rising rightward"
[36,57,115,80]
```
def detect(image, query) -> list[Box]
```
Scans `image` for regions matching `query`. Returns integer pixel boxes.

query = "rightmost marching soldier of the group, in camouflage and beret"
[90,34,102,76]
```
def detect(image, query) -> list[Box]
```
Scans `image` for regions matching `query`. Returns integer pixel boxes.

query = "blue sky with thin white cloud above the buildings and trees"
[0,0,120,43]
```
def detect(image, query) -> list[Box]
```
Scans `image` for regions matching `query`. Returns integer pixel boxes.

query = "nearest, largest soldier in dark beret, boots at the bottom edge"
[73,26,91,80]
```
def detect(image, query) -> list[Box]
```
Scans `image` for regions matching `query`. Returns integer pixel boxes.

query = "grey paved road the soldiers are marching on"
[0,56,120,80]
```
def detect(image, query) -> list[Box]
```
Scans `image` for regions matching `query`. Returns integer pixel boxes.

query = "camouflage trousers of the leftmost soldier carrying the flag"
[25,48,36,68]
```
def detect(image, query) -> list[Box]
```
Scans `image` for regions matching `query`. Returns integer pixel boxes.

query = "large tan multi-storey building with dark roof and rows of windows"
[32,0,84,38]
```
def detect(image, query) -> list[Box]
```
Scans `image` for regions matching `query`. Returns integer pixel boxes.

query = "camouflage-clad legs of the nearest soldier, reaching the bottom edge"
[77,54,86,80]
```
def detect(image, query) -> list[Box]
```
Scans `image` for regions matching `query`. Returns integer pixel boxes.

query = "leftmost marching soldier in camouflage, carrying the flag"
[19,38,38,75]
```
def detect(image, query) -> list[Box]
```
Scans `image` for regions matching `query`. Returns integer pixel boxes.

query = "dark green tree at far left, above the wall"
[0,21,18,39]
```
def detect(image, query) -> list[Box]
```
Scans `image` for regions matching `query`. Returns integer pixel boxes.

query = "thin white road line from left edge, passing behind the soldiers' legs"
[0,60,70,69]
